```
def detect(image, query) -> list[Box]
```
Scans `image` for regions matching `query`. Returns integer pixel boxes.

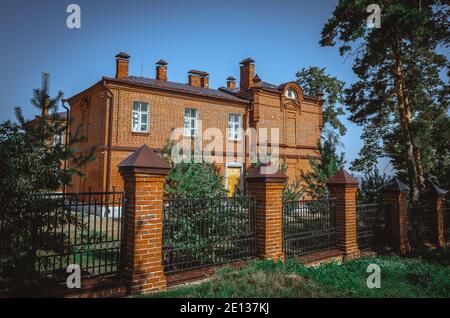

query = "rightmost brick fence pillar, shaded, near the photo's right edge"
[425,178,447,247]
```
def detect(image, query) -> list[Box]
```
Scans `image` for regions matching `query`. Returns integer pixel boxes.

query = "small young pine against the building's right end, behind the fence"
[302,136,345,199]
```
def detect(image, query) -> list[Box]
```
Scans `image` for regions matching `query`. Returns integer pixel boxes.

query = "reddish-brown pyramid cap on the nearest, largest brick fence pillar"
[119,145,170,175]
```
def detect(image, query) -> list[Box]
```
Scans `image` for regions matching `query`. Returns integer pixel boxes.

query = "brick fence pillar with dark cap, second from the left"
[246,167,287,260]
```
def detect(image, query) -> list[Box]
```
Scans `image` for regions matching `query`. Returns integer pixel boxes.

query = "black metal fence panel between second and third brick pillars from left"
[283,199,336,256]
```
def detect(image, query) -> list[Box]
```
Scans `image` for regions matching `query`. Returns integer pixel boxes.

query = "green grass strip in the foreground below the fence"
[146,249,450,298]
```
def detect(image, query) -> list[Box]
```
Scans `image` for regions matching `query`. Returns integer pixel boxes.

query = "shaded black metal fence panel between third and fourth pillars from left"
[356,203,389,250]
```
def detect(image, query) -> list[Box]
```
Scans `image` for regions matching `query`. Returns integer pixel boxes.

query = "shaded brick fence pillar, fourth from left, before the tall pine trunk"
[381,177,411,254]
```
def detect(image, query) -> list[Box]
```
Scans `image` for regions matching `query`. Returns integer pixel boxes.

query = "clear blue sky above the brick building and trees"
[0,0,394,174]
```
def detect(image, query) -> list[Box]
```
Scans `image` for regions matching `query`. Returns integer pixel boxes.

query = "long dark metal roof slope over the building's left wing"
[103,76,249,103]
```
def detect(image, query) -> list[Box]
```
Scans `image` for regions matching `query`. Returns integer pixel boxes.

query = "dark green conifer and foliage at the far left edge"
[0,74,93,288]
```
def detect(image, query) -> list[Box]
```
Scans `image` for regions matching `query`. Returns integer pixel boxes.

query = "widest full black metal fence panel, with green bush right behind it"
[163,197,256,273]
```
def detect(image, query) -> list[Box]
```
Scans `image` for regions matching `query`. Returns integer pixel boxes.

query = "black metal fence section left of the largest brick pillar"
[0,192,125,288]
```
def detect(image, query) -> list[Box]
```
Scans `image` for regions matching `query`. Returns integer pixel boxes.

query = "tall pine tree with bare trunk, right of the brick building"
[320,0,450,201]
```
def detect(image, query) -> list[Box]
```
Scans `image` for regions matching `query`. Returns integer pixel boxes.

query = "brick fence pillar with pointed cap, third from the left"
[327,169,360,258]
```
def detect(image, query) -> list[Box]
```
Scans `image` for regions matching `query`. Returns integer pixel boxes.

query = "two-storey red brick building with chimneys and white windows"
[67,53,323,191]
